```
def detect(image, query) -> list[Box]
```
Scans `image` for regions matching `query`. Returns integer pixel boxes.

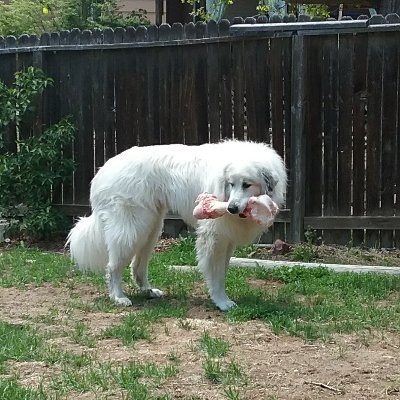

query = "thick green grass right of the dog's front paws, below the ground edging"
[227,267,400,340]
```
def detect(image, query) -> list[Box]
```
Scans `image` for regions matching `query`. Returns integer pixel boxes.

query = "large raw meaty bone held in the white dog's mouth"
[193,193,279,227]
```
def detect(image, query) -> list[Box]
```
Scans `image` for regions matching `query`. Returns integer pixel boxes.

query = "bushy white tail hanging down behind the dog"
[66,214,108,272]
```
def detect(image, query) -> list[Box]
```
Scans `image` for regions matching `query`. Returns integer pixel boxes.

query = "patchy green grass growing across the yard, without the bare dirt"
[0,239,400,400]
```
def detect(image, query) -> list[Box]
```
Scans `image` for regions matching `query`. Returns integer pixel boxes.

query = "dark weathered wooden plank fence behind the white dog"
[0,14,400,247]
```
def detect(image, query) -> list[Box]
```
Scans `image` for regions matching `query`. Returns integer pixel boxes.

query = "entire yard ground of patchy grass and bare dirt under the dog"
[0,239,400,400]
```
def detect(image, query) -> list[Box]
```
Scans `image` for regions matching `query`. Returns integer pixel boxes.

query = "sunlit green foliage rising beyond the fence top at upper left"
[0,0,149,35]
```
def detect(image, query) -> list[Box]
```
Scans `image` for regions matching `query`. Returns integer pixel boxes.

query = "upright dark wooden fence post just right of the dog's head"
[290,35,307,243]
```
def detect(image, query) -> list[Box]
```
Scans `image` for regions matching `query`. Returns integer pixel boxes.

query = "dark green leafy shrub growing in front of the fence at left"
[0,67,75,237]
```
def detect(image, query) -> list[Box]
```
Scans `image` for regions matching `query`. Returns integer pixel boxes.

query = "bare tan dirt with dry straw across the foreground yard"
[0,280,400,400]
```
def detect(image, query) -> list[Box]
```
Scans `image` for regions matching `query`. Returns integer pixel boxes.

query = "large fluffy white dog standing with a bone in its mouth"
[67,140,286,310]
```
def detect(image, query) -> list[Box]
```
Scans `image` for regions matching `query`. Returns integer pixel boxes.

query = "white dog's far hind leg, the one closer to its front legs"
[130,215,163,298]
